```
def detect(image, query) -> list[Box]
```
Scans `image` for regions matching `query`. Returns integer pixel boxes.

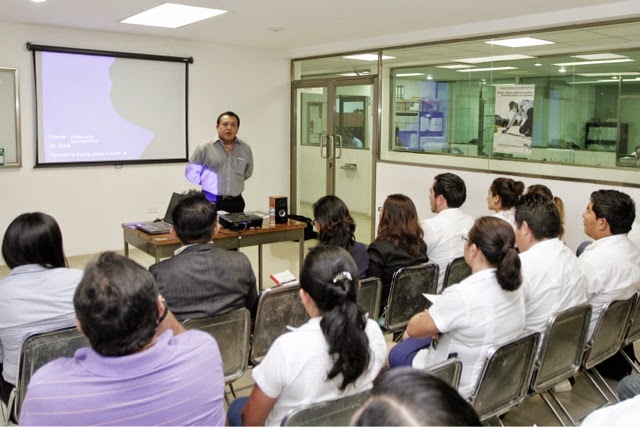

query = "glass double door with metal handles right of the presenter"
[291,77,377,243]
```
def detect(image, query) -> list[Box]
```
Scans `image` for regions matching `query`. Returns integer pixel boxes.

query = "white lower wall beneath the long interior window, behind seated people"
[376,162,640,251]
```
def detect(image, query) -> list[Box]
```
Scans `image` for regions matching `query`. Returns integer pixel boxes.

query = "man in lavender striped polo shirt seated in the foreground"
[20,252,225,426]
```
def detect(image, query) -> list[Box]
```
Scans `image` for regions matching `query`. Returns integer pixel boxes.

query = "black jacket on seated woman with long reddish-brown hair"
[367,239,429,307]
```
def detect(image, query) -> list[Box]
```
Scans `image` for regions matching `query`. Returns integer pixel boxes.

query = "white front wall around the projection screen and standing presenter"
[0,23,290,264]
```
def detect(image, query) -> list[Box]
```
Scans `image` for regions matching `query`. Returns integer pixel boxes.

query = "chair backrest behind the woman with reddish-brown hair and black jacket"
[384,264,438,332]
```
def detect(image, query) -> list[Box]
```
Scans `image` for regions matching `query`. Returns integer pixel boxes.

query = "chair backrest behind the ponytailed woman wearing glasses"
[471,332,540,421]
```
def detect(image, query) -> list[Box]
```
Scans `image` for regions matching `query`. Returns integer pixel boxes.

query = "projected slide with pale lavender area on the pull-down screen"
[36,47,187,165]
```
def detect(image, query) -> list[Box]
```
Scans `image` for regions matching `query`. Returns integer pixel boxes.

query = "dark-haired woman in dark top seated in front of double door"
[313,195,369,279]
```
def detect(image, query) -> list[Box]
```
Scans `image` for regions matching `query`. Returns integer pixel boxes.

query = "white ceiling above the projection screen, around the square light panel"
[0,0,624,49]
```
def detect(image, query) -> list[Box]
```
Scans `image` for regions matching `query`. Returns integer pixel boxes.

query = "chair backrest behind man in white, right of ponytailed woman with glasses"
[531,304,591,393]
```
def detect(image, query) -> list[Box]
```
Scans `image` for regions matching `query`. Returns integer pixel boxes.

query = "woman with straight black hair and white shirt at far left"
[0,212,82,404]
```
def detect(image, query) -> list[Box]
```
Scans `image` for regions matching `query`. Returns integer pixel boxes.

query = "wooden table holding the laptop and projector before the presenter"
[122,219,307,289]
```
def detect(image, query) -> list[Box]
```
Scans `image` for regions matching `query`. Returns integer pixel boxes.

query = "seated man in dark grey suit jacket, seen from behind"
[149,191,258,320]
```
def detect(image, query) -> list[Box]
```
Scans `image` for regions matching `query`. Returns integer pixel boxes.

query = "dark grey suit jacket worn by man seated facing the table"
[149,243,258,320]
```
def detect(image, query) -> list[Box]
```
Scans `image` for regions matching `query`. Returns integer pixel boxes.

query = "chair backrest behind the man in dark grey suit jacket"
[182,308,251,384]
